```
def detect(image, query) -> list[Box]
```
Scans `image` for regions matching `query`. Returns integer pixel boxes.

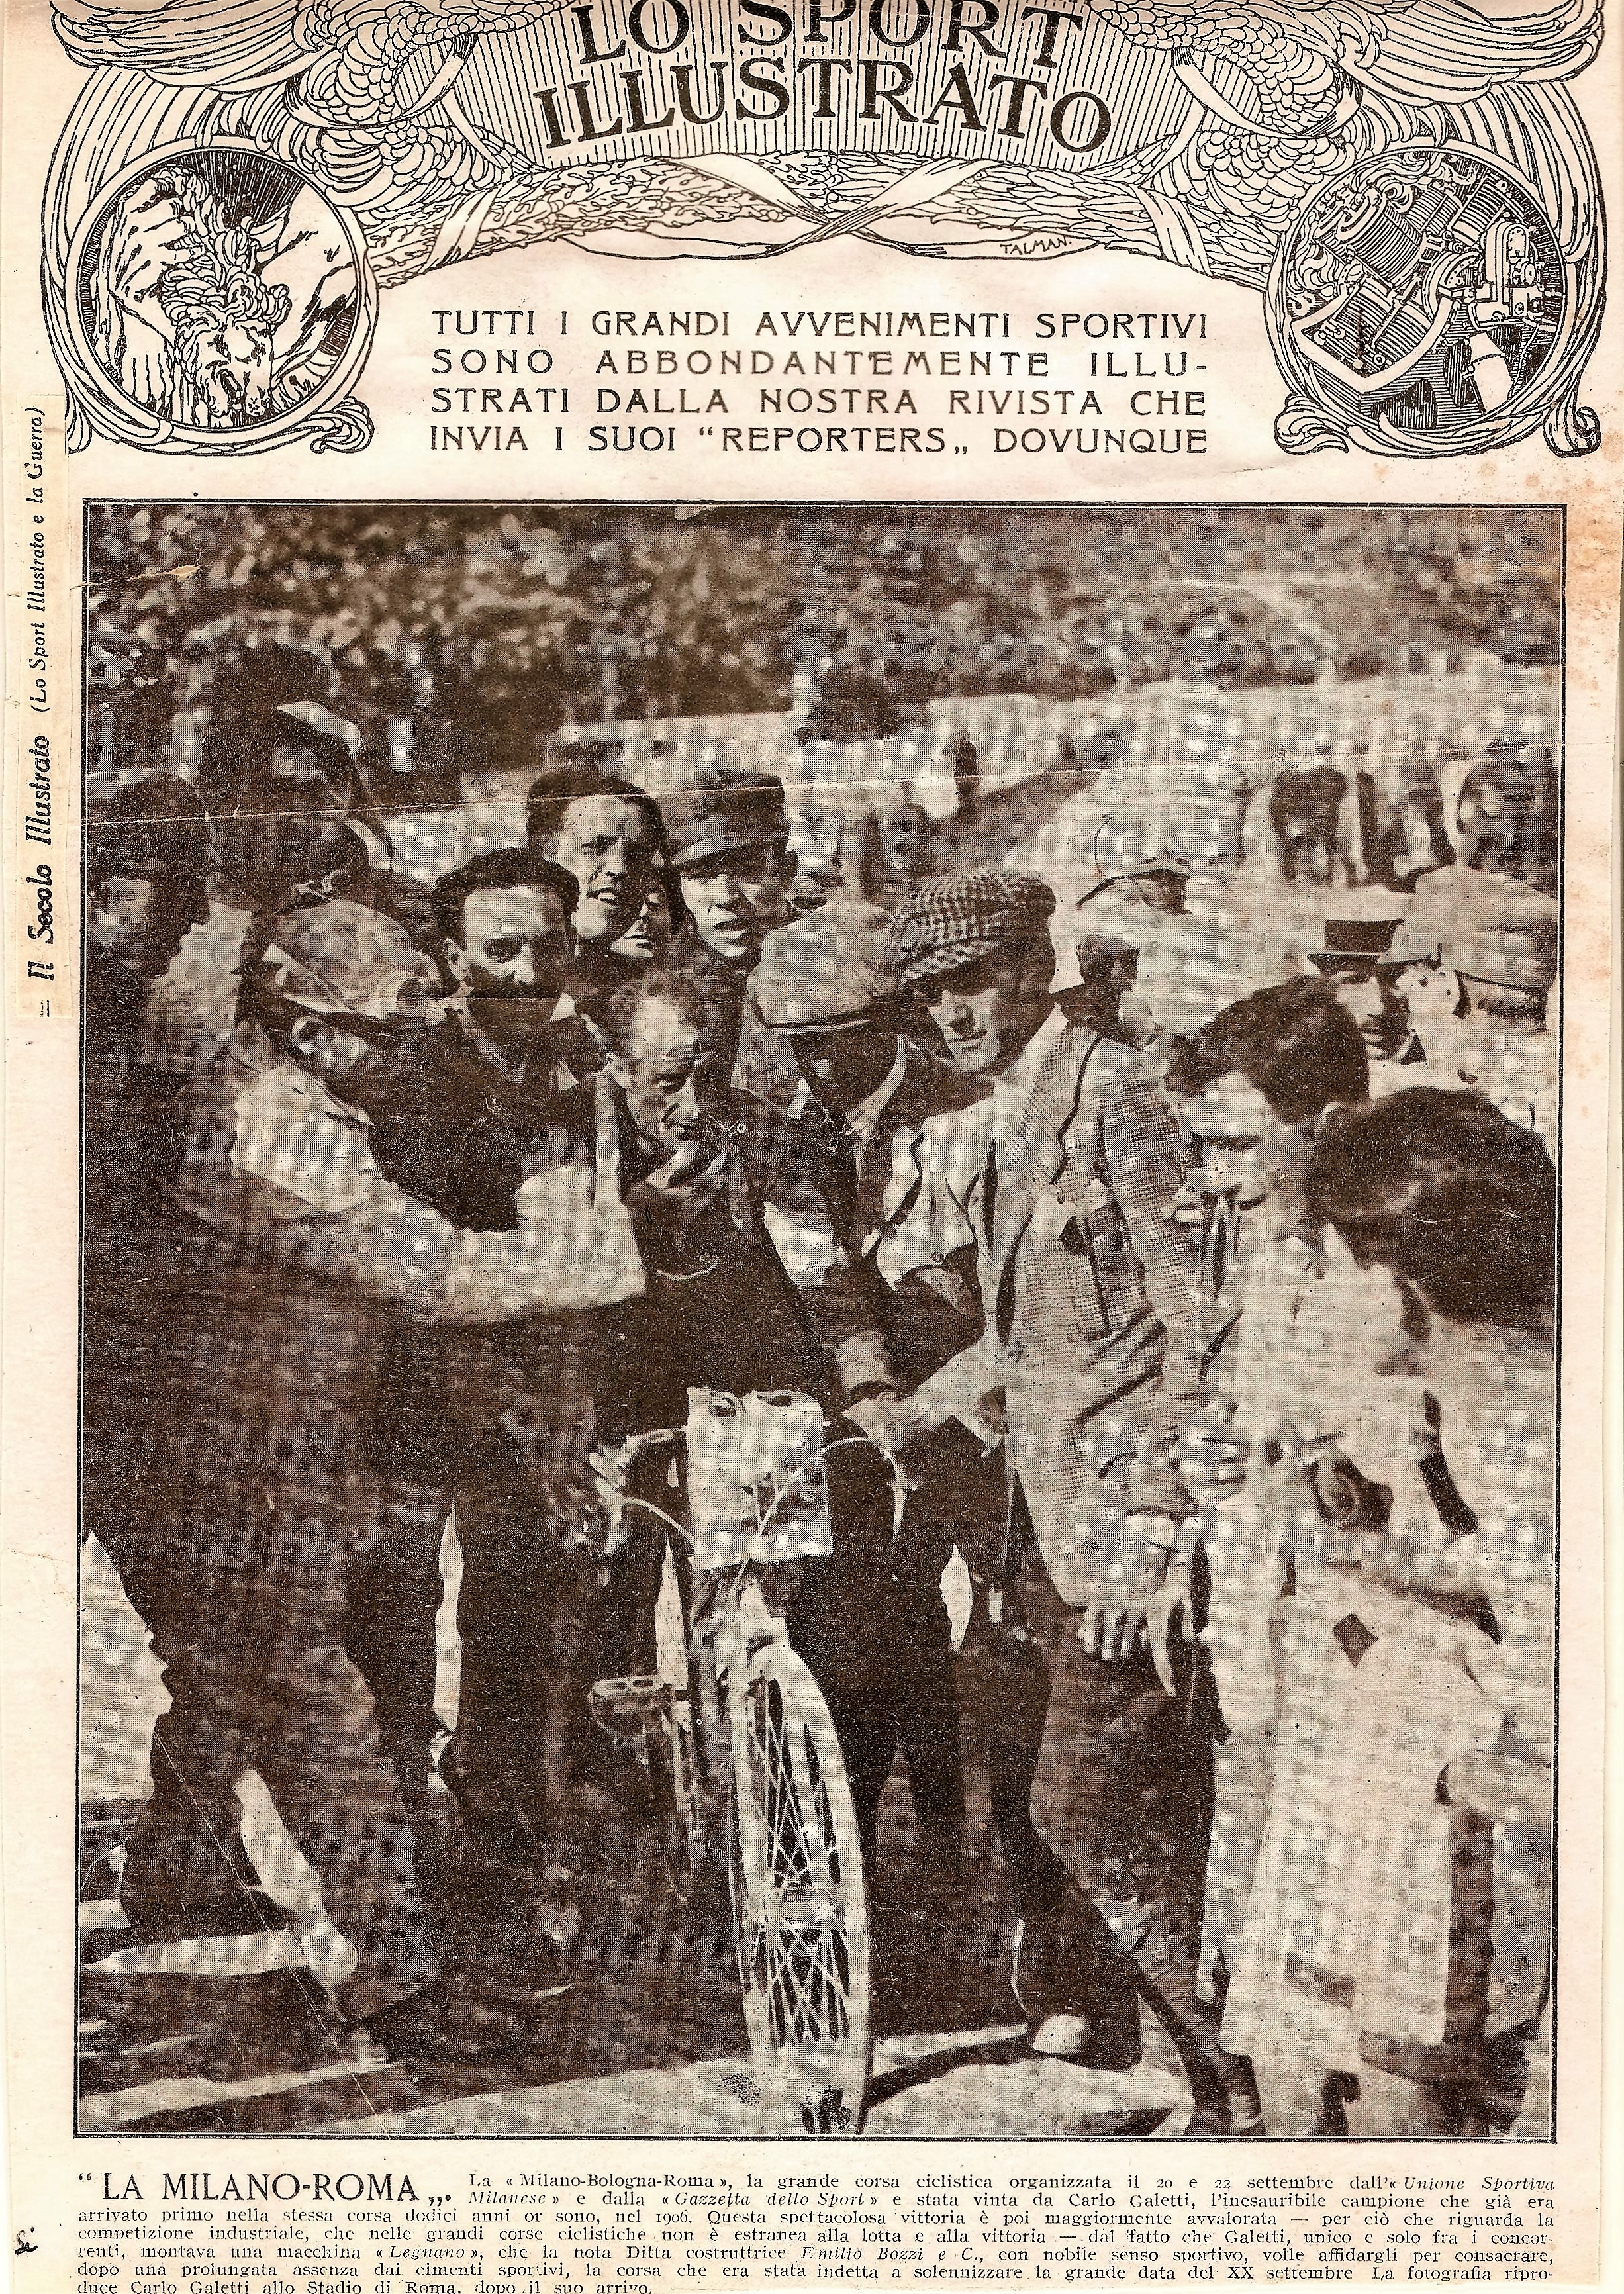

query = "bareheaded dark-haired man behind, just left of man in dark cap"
[525,764,665,1012]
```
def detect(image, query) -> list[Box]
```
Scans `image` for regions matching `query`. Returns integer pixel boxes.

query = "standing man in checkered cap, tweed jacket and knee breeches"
[892,869,1239,2133]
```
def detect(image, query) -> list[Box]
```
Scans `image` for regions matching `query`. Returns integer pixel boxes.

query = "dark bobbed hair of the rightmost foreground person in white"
[1308,1090,1558,1340]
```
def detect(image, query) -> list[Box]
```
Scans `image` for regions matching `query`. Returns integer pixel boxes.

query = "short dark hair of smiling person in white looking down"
[1168,980,1369,1124]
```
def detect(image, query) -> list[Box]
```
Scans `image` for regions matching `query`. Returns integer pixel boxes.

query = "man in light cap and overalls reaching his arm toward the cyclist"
[122,902,645,2060]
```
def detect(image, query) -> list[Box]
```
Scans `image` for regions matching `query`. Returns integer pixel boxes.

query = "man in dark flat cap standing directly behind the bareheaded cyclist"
[661,764,800,1108]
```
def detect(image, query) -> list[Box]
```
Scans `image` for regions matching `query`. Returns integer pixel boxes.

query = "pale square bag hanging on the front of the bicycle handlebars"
[688,1386,835,1569]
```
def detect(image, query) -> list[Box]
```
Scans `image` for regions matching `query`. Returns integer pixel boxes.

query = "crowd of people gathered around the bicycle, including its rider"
[83,702,1558,2136]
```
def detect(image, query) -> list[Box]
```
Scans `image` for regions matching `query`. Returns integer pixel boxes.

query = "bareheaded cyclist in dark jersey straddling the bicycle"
[516,968,897,1851]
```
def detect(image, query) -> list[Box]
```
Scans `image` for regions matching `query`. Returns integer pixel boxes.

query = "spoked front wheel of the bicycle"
[730,1640,872,2136]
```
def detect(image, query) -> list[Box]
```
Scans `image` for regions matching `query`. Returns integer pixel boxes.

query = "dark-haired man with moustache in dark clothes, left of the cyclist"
[424,849,619,1943]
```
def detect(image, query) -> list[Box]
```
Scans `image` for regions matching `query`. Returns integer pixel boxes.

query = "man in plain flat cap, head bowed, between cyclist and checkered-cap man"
[747,899,1002,1888]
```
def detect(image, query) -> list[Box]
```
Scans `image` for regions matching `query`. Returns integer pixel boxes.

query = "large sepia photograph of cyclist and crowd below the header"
[78,493,1564,2142]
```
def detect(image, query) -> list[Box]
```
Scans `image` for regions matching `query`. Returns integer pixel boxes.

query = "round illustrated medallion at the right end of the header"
[1266,142,1571,454]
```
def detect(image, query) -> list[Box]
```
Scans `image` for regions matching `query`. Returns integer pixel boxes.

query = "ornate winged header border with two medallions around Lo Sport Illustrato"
[44,0,1603,459]
